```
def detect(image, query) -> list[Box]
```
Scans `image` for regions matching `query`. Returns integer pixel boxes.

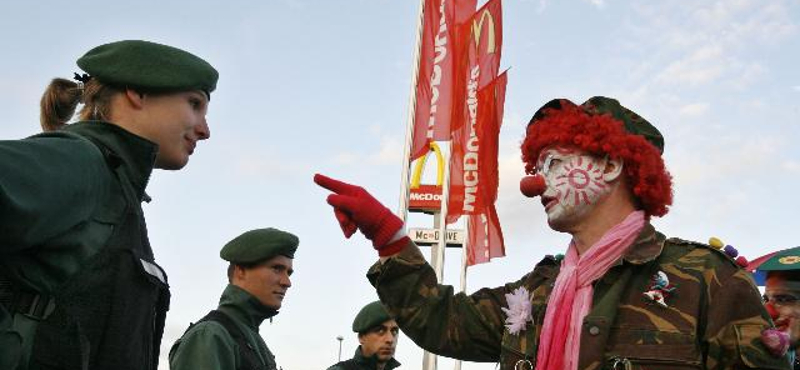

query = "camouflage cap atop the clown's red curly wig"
[529,96,664,154]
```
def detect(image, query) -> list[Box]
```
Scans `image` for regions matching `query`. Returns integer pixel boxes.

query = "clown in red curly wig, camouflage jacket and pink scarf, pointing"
[315,97,788,370]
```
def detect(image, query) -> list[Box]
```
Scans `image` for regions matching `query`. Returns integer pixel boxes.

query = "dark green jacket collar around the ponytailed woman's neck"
[64,121,158,201]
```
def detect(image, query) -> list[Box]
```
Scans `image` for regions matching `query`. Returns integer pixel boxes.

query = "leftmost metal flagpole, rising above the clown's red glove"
[397,0,425,222]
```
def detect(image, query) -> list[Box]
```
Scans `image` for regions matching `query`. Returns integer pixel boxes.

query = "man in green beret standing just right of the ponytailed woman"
[169,228,299,370]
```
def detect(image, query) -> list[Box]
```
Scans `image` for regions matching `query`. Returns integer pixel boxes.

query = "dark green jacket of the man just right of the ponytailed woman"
[169,284,278,370]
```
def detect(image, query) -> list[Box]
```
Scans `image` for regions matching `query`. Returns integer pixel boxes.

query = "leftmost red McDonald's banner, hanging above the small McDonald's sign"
[410,0,477,161]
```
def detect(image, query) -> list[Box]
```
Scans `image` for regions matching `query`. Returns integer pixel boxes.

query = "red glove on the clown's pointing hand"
[314,174,408,256]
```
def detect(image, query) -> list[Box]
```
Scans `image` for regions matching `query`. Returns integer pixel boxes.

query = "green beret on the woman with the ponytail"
[78,40,219,95]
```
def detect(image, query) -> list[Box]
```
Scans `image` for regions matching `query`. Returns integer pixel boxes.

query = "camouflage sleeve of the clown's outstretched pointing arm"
[367,243,520,362]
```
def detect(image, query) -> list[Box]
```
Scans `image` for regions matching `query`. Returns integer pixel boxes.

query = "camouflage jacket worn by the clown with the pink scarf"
[367,224,789,370]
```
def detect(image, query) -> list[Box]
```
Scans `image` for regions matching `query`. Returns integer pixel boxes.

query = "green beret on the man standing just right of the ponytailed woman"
[219,227,300,264]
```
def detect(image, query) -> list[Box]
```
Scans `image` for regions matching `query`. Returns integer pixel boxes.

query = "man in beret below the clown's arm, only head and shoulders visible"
[328,301,400,370]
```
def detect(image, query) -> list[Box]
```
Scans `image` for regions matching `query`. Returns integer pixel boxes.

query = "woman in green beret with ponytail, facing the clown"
[0,40,218,370]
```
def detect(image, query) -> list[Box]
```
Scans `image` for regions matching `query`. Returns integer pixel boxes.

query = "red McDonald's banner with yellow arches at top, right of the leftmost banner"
[447,0,506,223]
